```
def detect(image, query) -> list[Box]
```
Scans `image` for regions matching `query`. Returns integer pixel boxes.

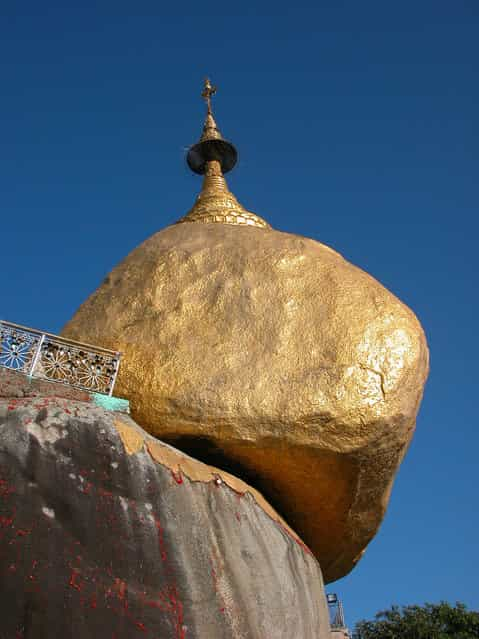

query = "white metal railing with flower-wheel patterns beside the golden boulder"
[0,321,121,395]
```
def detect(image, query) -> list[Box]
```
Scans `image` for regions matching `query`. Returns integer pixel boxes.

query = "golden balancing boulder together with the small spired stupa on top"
[63,81,428,582]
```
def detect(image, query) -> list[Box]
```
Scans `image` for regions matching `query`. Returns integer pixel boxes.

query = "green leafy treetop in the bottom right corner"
[353,601,479,639]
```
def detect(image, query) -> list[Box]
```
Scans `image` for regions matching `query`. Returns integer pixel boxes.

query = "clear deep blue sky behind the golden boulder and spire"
[0,0,479,625]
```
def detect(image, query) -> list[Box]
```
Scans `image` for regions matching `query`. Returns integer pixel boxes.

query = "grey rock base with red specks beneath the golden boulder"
[0,387,329,639]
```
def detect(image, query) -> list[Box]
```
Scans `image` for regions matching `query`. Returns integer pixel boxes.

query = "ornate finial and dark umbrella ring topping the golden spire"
[186,78,238,175]
